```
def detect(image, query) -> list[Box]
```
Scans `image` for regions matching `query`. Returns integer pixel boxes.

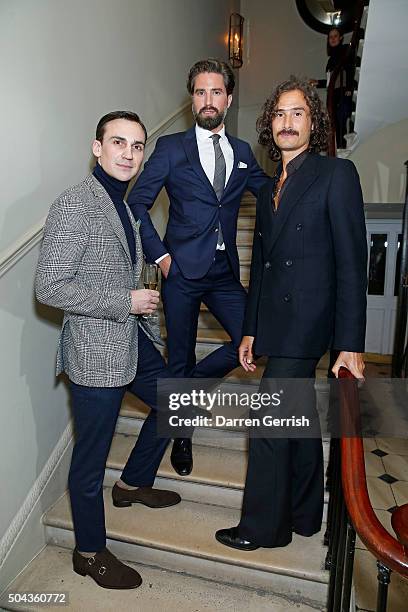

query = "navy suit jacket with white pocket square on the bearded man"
[127,127,267,279]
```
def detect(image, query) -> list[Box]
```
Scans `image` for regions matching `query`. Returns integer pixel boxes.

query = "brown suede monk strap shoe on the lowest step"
[72,548,142,589]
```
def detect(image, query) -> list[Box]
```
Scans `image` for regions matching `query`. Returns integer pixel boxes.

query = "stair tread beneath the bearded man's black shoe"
[107,433,247,489]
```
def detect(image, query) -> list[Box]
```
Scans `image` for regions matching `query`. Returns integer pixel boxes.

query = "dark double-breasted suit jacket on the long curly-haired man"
[243,153,367,358]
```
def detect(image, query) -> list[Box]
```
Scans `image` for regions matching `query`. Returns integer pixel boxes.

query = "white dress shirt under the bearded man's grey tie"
[156,124,234,264]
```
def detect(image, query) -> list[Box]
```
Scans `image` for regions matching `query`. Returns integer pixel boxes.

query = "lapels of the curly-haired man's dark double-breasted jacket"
[268,154,318,253]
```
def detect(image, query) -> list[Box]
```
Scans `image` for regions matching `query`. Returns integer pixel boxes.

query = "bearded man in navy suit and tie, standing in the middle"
[128,59,267,475]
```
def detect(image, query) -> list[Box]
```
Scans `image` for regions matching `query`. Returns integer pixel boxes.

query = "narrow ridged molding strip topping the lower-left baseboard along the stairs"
[0,422,73,568]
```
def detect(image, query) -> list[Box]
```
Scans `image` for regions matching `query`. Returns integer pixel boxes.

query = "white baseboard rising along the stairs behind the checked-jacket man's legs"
[0,423,72,593]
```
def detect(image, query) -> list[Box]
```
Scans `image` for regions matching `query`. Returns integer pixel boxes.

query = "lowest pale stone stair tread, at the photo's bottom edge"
[0,545,316,612]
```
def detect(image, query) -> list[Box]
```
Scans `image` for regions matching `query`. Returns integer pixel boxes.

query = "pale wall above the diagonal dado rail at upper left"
[0,0,237,253]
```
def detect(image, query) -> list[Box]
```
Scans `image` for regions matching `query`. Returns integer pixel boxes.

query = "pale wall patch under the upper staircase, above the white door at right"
[350,118,408,204]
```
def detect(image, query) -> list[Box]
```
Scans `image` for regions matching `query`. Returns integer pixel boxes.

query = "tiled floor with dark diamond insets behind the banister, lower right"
[354,363,408,612]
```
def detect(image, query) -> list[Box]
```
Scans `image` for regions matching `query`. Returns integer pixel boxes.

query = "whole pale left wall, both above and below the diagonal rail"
[0,0,237,560]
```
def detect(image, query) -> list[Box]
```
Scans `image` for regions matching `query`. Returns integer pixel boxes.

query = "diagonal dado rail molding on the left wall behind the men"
[0,101,191,280]
